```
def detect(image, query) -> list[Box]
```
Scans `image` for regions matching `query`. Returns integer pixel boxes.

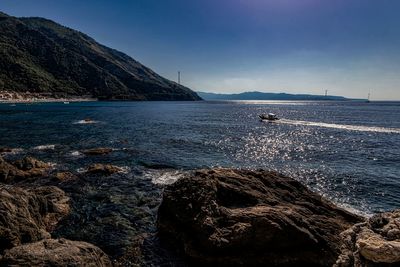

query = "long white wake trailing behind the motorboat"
[278,119,400,134]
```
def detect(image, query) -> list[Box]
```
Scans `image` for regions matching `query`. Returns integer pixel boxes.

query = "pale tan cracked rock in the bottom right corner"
[335,210,400,267]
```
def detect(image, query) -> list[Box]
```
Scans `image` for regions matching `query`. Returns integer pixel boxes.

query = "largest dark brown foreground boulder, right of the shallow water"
[158,169,362,266]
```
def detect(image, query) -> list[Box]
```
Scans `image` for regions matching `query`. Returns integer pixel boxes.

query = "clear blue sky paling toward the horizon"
[0,0,400,100]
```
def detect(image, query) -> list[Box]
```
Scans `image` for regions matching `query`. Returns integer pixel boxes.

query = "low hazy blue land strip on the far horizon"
[197,91,365,101]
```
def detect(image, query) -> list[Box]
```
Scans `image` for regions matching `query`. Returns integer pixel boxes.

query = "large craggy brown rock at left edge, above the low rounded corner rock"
[0,185,69,253]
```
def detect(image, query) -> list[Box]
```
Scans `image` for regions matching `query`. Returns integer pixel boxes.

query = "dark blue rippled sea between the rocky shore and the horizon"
[0,101,400,214]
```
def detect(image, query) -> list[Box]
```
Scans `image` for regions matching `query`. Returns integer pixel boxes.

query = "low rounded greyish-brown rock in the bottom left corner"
[0,239,112,266]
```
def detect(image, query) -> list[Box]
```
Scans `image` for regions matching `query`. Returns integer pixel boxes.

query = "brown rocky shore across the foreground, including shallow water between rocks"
[0,154,400,267]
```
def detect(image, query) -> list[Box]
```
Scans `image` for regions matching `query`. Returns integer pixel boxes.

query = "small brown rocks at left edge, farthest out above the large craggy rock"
[0,157,51,183]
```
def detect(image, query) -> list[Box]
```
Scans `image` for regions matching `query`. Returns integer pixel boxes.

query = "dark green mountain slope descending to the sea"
[0,12,200,100]
